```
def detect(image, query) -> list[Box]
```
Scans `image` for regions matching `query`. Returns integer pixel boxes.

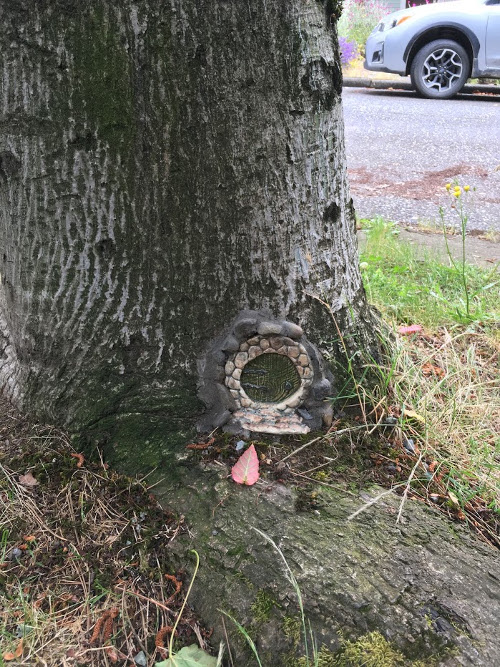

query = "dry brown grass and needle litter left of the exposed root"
[0,405,207,666]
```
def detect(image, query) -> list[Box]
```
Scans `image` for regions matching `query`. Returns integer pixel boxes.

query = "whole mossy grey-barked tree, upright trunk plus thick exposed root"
[0,0,500,667]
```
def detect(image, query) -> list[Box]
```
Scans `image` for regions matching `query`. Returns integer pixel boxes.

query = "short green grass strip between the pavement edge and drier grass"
[361,218,500,337]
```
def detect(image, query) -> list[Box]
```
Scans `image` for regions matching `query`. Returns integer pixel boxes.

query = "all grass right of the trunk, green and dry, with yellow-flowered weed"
[358,218,500,543]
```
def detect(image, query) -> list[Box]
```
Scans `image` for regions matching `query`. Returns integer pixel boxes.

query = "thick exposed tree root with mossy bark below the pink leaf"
[156,466,500,667]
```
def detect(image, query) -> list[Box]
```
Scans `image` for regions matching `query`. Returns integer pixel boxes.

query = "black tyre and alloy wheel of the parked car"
[410,39,470,99]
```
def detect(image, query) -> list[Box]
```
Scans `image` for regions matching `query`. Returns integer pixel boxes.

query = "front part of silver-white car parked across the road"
[365,0,500,99]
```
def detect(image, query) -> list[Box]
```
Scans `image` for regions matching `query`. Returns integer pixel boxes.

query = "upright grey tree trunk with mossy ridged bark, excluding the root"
[0,0,373,456]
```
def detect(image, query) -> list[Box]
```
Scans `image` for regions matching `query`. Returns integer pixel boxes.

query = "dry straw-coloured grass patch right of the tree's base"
[365,329,500,546]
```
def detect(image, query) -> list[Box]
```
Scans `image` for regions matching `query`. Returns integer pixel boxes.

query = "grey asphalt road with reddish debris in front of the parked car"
[343,88,500,232]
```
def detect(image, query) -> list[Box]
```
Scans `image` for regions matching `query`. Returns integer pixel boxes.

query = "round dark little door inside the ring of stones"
[240,354,301,403]
